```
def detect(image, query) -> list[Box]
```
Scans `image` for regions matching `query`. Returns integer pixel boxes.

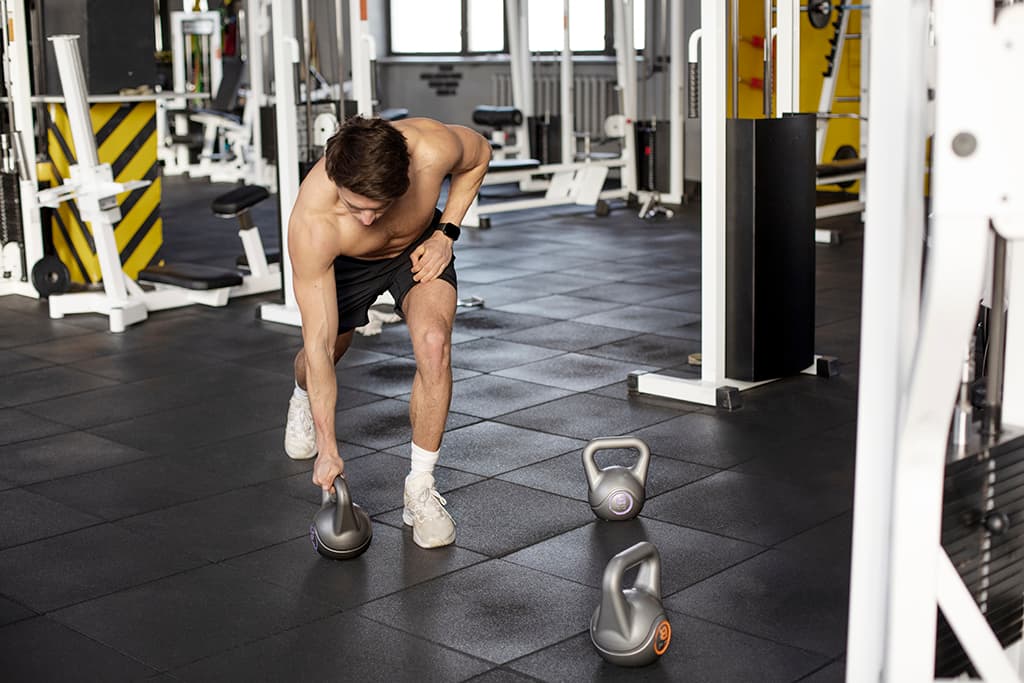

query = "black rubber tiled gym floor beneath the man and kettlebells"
[0,178,862,683]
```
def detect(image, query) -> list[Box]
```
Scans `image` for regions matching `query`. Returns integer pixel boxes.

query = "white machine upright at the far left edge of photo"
[0,0,43,298]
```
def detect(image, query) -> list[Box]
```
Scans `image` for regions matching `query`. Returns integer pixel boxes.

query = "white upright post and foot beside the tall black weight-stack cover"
[629,0,816,405]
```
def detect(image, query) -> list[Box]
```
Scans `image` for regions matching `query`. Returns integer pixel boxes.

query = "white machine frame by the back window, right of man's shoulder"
[462,0,634,227]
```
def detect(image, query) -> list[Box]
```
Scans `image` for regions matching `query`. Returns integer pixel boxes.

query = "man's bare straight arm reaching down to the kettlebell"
[288,216,344,490]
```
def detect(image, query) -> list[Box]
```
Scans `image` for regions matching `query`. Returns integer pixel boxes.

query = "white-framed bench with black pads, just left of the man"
[138,185,281,310]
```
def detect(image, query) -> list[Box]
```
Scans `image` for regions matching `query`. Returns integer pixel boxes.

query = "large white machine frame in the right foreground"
[846,0,1024,683]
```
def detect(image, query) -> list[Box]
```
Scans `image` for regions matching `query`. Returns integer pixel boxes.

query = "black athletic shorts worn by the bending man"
[334,209,459,335]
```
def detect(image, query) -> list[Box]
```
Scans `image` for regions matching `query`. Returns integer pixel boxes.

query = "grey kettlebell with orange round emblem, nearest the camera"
[590,541,672,667]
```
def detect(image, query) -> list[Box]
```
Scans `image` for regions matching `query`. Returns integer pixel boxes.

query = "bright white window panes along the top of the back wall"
[388,0,646,54]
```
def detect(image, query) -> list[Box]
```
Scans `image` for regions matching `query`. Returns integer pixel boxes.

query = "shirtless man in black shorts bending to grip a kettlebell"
[285,117,490,548]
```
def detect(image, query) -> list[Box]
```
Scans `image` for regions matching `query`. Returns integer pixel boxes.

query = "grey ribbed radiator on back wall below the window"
[490,74,618,140]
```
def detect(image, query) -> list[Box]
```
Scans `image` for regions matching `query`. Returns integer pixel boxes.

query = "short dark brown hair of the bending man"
[324,116,409,202]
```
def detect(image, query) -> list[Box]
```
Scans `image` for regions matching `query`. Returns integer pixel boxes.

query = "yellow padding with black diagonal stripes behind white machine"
[46,101,164,283]
